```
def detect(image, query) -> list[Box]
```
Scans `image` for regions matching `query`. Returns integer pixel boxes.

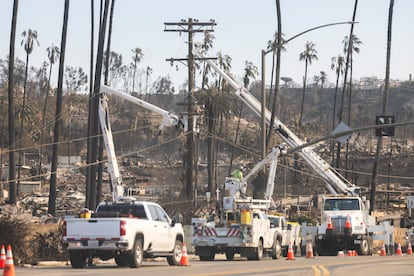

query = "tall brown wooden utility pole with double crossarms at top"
[164,18,216,198]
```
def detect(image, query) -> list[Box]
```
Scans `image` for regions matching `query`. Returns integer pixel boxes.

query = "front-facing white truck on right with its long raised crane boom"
[194,45,375,255]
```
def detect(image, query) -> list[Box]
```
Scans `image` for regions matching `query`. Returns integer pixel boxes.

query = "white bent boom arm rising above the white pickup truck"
[98,85,185,201]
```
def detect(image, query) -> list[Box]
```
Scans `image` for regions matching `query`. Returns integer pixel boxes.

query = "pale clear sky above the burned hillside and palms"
[0,0,414,91]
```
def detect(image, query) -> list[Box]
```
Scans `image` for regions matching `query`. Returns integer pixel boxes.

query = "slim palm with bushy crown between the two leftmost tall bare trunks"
[17,29,39,183]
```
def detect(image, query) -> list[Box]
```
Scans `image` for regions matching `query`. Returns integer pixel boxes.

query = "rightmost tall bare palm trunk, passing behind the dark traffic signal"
[370,0,394,212]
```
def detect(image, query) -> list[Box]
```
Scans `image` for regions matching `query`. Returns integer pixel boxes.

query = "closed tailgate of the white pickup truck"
[65,218,121,240]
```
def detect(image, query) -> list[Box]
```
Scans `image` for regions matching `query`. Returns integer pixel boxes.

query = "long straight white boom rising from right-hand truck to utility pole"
[194,47,359,195]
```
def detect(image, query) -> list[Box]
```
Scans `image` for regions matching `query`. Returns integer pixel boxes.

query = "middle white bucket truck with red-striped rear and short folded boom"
[192,146,300,261]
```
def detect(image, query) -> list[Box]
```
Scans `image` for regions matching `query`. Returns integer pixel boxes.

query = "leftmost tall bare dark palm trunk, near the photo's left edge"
[7,0,19,204]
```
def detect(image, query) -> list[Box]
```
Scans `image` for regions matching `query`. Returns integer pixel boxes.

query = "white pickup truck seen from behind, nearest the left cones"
[63,200,184,268]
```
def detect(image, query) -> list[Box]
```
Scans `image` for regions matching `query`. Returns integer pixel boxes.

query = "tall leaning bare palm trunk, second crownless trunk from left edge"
[47,0,69,216]
